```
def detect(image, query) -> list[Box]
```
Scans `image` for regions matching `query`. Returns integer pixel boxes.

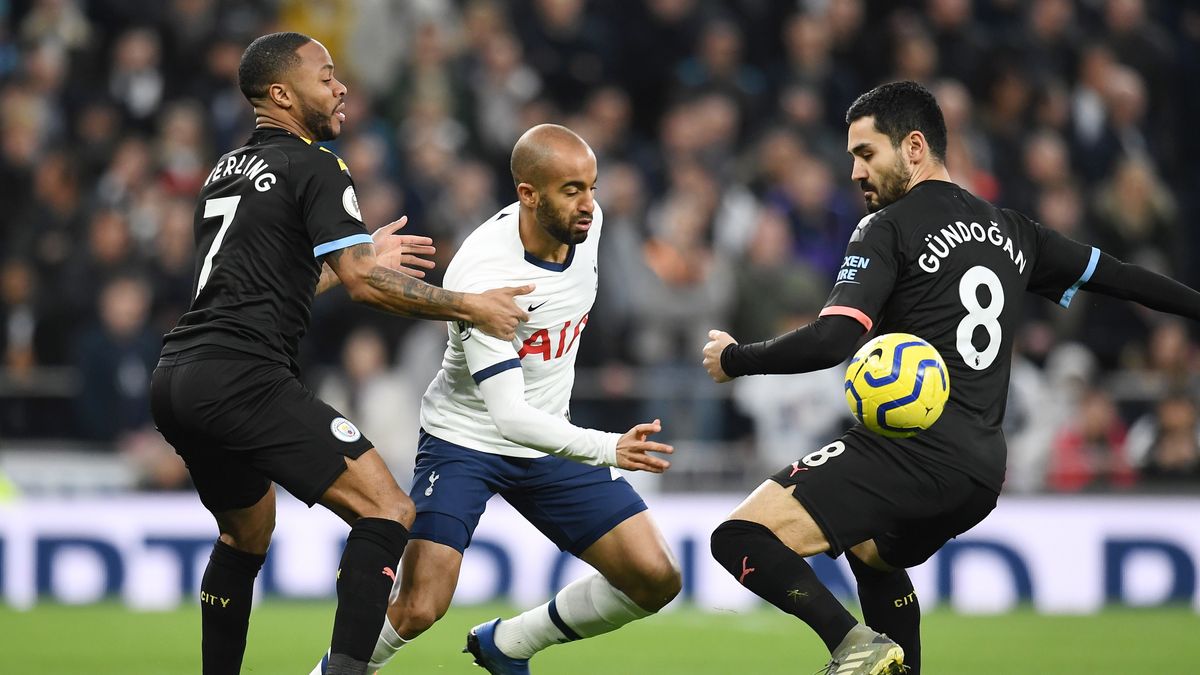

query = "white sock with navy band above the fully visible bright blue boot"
[496,574,654,658]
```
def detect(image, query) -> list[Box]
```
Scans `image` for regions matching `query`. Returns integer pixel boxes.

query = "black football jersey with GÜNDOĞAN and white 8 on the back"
[821,180,1100,491]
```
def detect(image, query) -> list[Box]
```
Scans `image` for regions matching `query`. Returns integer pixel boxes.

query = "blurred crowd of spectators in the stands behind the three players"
[0,0,1200,491]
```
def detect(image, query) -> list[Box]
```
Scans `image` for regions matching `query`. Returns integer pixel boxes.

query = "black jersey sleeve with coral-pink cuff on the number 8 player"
[821,215,900,330]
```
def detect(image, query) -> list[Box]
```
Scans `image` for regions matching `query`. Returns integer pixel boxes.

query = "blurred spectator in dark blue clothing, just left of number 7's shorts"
[76,276,162,442]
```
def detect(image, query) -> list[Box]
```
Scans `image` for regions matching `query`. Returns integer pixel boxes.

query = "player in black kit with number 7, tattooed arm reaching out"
[151,32,532,674]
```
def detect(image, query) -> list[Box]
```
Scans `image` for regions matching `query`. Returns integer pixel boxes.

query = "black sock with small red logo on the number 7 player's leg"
[328,518,408,675]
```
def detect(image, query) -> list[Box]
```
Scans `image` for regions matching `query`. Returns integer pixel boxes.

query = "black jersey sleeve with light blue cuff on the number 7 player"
[292,145,371,258]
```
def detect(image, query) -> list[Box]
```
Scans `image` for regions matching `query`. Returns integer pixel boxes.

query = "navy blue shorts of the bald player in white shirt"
[410,430,646,556]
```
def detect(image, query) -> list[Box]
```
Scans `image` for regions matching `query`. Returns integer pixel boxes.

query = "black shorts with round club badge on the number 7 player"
[150,356,373,513]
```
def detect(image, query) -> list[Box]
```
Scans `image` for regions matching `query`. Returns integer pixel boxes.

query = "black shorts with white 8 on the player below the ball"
[770,429,998,567]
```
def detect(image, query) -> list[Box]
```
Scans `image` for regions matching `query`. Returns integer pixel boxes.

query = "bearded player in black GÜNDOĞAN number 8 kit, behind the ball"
[703,82,1200,675]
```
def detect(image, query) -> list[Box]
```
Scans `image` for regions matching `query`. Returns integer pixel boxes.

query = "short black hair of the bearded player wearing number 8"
[846,82,946,165]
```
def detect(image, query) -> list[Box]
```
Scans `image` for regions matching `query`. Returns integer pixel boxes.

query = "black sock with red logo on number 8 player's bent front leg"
[712,520,858,652]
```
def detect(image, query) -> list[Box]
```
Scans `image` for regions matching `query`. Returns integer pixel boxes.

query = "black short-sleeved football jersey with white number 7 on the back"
[162,129,371,371]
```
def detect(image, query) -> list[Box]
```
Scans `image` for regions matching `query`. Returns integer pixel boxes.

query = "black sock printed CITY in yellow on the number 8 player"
[846,551,920,675]
